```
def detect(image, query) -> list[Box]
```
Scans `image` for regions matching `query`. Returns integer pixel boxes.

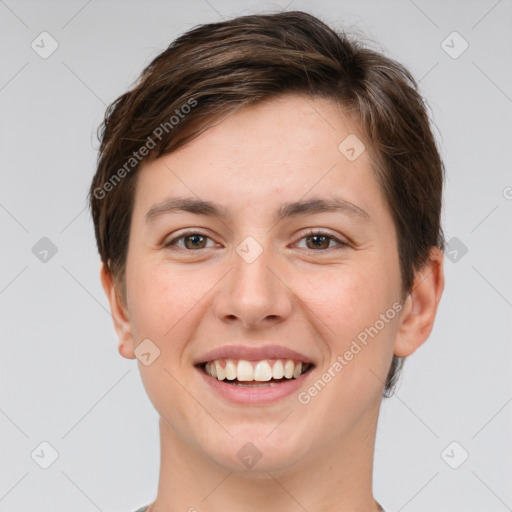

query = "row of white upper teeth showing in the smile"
[205,359,309,382]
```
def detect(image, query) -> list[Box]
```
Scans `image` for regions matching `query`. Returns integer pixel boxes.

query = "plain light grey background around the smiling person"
[0,0,512,512]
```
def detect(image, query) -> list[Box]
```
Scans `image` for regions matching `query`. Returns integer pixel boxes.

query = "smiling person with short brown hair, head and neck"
[90,12,444,512]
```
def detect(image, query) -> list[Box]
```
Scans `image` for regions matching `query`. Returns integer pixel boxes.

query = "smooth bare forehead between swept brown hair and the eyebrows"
[136,95,385,220]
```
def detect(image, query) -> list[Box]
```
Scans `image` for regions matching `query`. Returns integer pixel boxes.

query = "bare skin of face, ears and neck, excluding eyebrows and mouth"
[101,95,444,512]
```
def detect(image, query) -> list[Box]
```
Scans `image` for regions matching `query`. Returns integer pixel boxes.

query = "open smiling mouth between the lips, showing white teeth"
[196,359,314,388]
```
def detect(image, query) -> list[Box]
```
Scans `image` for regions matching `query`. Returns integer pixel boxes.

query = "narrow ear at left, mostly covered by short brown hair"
[100,262,135,359]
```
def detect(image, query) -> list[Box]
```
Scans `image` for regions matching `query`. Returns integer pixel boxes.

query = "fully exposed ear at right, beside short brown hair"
[393,247,444,357]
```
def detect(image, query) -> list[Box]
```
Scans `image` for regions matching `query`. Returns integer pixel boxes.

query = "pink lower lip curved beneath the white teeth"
[197,368,312,405]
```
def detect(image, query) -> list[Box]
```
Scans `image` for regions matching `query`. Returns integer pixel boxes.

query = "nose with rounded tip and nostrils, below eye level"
[213,239,293,329]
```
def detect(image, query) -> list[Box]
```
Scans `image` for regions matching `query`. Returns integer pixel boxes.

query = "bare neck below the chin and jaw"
[148,402,382,512]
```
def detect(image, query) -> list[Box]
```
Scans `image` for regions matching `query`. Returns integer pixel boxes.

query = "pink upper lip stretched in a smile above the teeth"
[195,342,313,364]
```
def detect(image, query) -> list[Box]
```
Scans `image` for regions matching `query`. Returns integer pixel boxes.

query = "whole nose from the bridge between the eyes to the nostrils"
[212,236,291,327]
